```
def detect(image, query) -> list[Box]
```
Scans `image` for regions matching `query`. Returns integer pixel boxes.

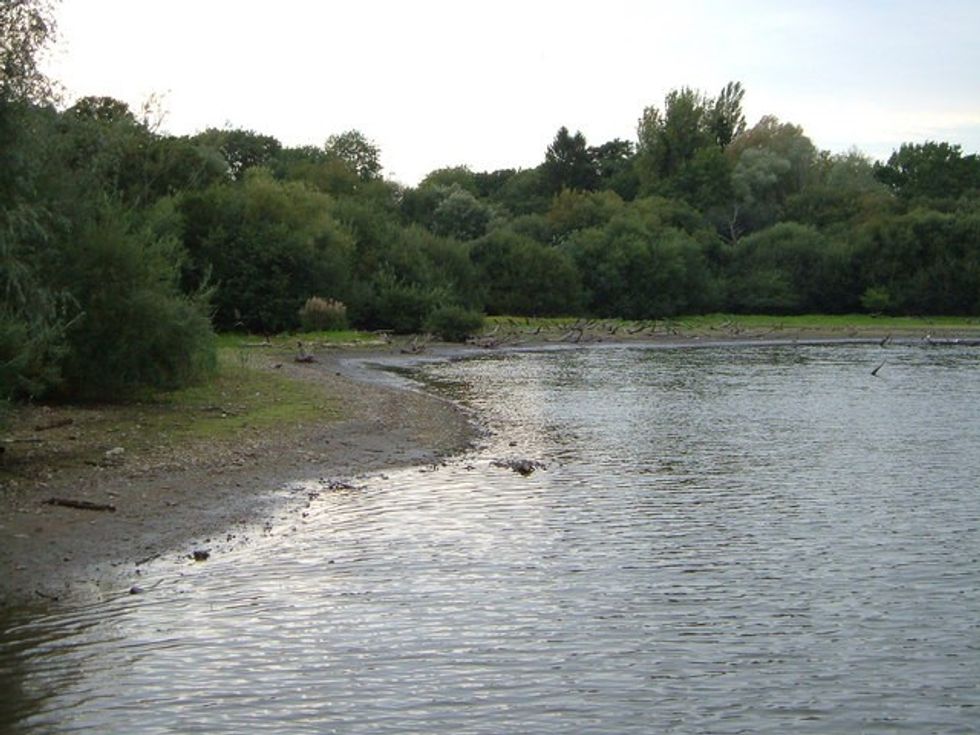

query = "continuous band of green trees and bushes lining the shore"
[0,0,980,406]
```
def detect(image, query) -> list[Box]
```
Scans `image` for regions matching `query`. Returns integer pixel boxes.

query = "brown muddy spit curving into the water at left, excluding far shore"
[0,349,476,605]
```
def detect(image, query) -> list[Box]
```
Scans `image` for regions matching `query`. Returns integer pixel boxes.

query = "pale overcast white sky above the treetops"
[42,0,980,184]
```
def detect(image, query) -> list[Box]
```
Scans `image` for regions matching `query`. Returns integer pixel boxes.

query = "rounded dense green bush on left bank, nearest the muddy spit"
[58,207,215,400]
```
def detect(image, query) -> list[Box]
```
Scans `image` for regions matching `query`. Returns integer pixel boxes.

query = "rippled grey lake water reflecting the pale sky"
[0,345,980,734]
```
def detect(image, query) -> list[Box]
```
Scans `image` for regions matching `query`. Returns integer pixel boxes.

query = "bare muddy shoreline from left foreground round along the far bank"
[0,319,980,607]
